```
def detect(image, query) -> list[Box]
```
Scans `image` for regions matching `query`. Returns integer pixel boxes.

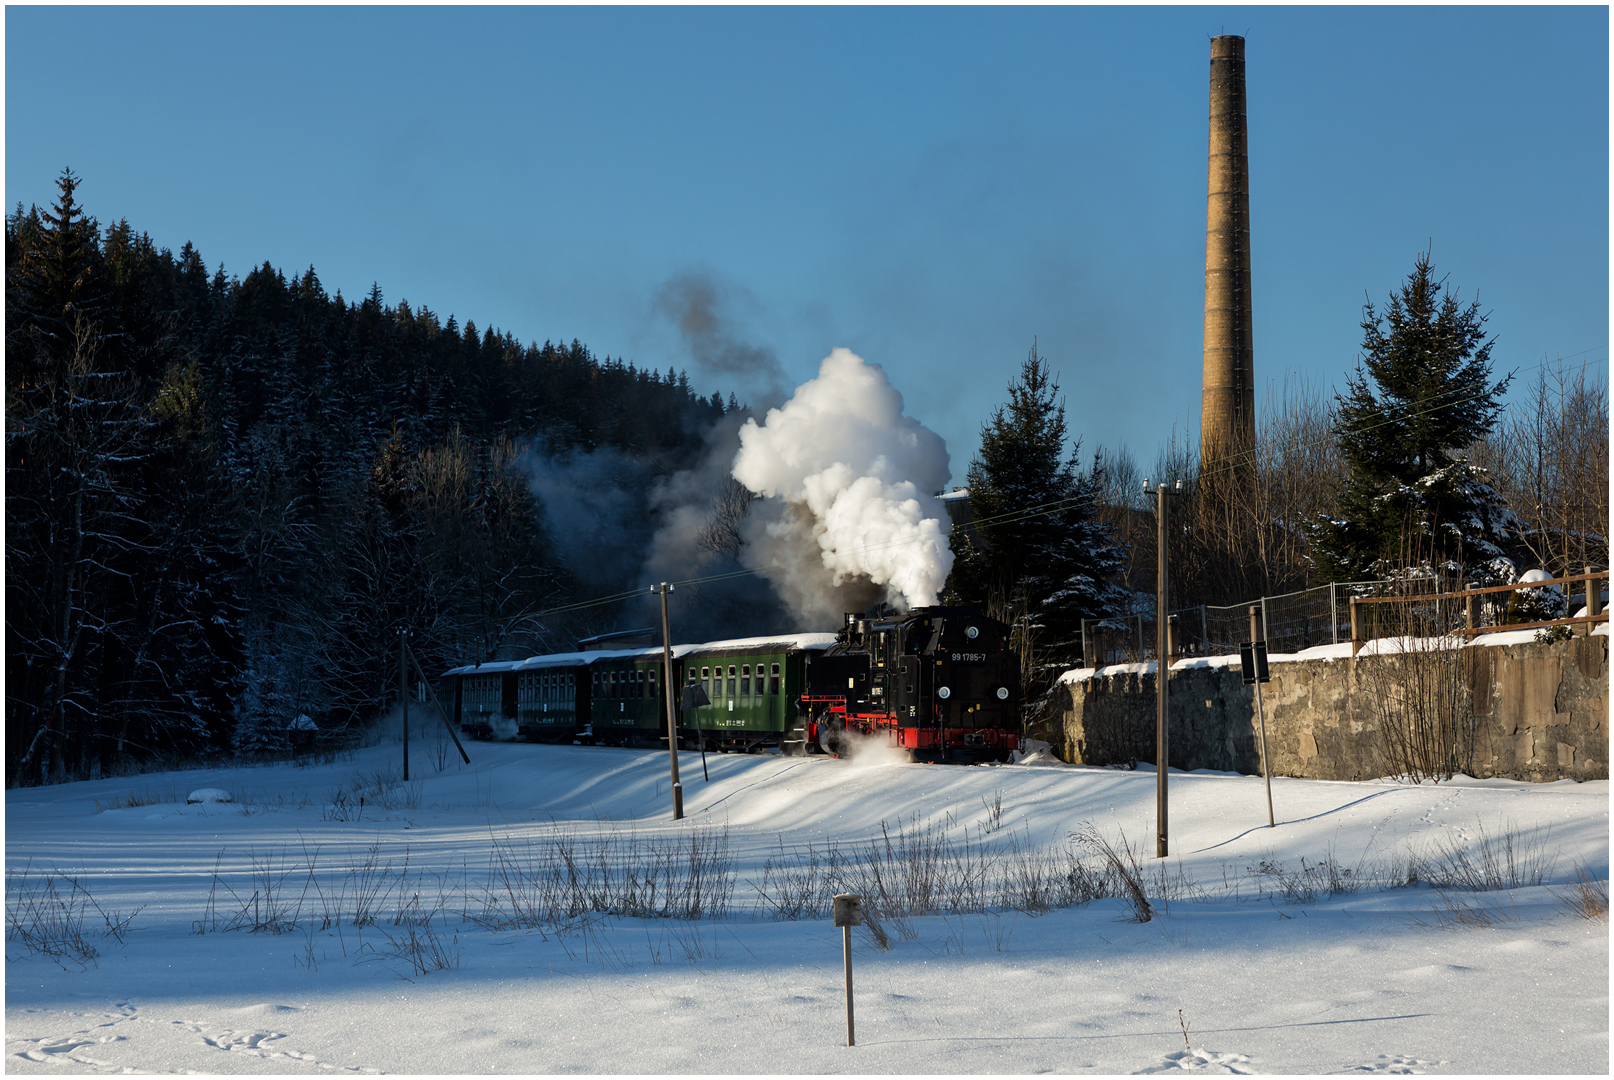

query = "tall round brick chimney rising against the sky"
[1199,36,1256,481]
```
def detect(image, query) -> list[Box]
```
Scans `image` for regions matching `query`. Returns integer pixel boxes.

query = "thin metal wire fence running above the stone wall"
[1081,581,1385,667]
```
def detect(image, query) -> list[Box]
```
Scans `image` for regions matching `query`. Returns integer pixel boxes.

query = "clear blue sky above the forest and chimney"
[5,6,1609,483]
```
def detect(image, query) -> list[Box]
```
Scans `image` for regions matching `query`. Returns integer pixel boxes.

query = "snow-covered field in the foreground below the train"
[5,739,1609,1074]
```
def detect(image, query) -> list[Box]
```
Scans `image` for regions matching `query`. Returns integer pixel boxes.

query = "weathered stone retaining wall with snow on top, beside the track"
[1028,636,1609,781]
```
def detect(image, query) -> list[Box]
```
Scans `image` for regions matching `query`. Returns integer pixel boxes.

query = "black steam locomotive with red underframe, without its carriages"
[801,607,1020,762]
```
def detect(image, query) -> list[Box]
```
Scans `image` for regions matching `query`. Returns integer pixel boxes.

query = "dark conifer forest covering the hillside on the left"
[6,173,725,785]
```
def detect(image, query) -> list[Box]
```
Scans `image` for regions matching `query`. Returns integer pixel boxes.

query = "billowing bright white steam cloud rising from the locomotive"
[733,349,952,622]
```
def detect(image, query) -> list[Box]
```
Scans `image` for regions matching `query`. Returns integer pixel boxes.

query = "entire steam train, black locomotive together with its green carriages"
[441,607,1020,762]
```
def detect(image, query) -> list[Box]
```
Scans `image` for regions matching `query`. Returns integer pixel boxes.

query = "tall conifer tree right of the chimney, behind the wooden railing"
[1312,253,1514,581]
